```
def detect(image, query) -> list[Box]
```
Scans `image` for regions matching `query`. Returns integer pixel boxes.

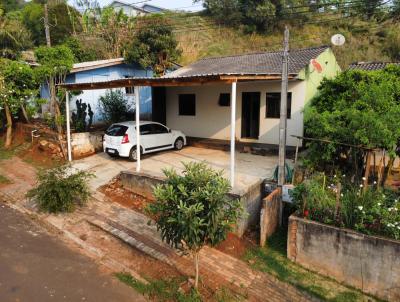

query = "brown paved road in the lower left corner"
[0,203,145,302]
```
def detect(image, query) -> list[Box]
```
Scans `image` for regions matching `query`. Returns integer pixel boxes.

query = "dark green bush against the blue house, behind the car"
[99,89,132,123]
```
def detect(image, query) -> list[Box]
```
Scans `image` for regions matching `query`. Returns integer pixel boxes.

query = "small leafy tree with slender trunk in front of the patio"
[148,162,243,288]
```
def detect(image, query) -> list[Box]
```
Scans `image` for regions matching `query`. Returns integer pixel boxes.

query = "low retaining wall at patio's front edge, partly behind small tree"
[120,171,262,237]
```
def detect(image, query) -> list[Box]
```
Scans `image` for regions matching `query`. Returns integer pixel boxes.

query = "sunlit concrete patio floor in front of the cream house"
[73,147,278,195]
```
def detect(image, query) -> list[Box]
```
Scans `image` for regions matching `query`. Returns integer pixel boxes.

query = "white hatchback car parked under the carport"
[103,121,186,161]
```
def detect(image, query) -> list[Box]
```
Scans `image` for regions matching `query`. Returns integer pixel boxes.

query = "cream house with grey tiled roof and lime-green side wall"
[159,46,341,146]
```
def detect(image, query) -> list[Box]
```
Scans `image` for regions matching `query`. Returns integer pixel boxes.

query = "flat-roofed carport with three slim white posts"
[59,74,281,187]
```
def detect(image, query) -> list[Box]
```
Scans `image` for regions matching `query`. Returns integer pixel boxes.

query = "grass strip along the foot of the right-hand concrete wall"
[244,229,375,302]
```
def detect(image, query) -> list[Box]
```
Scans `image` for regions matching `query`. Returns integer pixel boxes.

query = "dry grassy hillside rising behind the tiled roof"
[175,16,400,68]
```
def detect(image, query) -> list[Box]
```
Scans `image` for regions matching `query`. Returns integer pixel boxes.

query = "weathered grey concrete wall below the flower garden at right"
[287,215,400,301]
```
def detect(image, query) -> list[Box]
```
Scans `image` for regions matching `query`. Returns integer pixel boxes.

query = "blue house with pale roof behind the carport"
[41,58,153,124]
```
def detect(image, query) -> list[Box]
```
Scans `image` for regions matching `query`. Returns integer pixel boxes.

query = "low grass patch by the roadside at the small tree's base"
[115,273,244,302]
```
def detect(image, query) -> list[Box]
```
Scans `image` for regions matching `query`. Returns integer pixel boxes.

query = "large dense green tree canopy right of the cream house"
[305,65,400,175]
